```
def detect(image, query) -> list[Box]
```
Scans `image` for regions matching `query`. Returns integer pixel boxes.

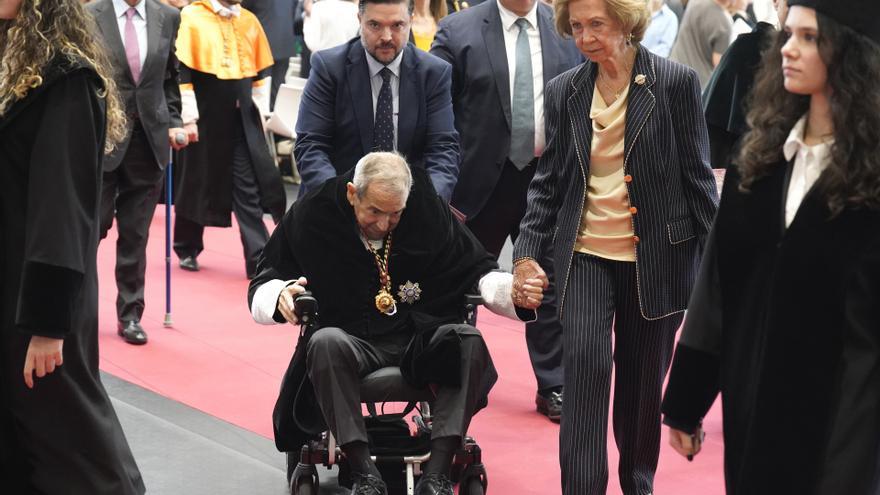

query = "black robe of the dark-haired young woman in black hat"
[663,163,880,495]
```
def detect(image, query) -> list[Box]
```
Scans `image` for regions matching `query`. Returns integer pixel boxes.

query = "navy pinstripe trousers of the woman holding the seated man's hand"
[559,253,684,495]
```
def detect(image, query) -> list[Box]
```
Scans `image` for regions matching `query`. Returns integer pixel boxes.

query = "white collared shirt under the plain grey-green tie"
[496,0,545,156]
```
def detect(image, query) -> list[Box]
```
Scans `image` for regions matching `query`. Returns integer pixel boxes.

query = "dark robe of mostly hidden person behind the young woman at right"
[703,22,776,169]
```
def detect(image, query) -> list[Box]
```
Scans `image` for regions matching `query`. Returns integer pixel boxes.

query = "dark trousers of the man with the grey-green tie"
[466,160,564,390]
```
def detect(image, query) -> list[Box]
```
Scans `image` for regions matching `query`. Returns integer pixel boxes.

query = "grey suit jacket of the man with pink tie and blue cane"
[86,0,183,172]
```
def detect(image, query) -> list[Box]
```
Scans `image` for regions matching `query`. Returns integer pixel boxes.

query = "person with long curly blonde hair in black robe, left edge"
[0,0,144,495]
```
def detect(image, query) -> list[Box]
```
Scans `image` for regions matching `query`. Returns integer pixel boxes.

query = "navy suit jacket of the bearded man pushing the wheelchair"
[293,38,459,200]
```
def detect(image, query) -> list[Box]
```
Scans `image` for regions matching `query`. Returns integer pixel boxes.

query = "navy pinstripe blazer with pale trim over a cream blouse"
[514,46,717,319]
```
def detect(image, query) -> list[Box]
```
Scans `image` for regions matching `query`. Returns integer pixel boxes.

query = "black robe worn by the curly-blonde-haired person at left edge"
[0,57,144,495]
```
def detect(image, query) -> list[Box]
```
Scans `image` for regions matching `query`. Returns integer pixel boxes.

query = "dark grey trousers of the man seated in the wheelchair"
[306,325,491,445]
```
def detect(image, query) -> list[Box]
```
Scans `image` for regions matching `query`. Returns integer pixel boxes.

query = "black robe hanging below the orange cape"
[174,65,285,227]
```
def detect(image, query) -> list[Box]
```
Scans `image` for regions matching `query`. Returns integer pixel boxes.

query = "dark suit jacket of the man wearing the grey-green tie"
[431,1,583,217]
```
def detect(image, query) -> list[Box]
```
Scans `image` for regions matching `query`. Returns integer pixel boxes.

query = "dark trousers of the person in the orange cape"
[174,120,269,278]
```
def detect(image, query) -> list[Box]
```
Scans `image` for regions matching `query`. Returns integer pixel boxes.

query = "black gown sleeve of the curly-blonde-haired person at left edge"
[15,70,105,338]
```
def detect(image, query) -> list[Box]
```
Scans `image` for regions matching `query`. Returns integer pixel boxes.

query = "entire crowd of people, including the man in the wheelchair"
[0,0,880,495]
